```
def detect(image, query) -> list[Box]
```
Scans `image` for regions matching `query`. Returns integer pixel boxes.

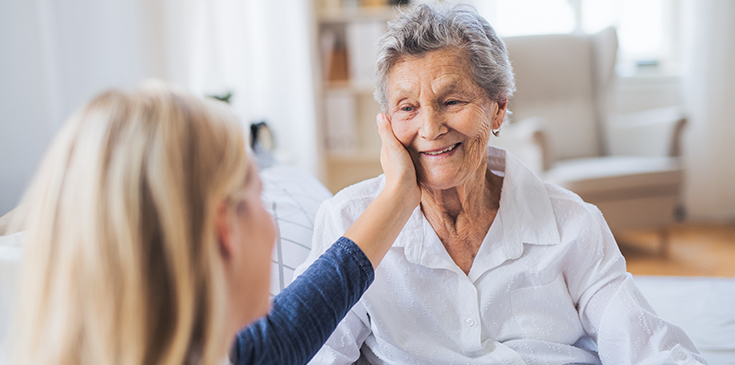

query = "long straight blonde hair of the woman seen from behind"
[14,83,249,364]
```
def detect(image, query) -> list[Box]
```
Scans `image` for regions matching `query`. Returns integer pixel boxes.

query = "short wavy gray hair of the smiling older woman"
[373,4,515,111]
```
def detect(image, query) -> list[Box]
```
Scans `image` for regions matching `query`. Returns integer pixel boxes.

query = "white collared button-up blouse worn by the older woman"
[297,147,705,364]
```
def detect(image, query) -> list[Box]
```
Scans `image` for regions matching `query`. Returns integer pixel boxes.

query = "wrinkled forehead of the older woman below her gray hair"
[388,48,479,97]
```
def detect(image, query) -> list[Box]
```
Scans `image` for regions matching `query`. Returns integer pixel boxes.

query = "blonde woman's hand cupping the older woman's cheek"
[376,113,421,207]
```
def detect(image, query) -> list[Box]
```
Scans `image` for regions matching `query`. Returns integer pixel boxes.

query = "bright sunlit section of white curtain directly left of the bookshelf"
[147,0,321,175]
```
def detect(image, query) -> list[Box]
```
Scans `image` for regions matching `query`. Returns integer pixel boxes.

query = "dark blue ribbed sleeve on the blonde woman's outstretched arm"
[231,237,375,365]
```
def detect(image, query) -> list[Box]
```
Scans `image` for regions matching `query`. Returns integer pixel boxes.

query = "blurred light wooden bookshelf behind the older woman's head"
[313,0,399,193]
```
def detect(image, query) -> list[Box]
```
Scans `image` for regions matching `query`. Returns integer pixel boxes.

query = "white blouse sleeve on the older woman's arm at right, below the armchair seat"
[570,207,706,364]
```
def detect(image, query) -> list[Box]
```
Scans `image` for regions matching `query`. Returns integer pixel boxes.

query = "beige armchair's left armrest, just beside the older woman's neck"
[490,117,553,174]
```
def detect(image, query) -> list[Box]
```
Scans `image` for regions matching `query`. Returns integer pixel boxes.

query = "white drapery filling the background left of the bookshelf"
[0,0,321,215]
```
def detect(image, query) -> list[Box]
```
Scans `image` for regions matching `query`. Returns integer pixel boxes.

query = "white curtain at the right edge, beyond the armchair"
[682,0,735,221]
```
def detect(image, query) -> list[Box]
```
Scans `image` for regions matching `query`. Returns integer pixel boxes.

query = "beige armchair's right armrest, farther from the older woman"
[607,107,686,157]
